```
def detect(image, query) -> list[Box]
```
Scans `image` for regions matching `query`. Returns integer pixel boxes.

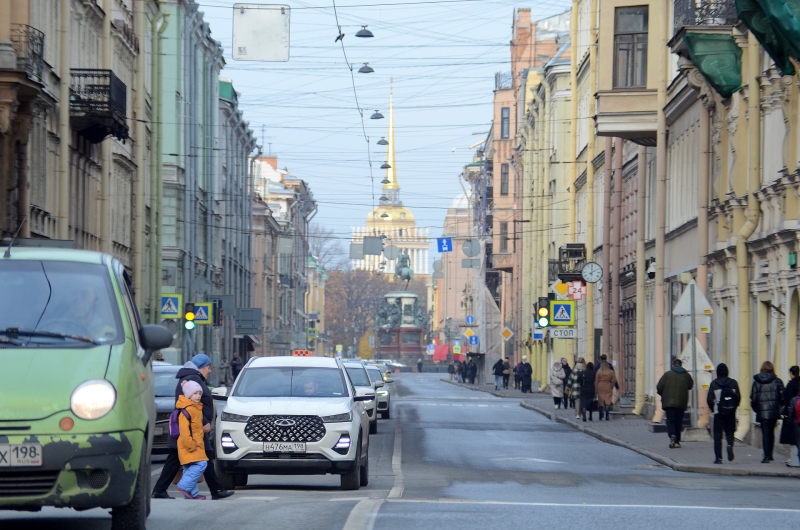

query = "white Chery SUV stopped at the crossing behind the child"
[214,357,375,490]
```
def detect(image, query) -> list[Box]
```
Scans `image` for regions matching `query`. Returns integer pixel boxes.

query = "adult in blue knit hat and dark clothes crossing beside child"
[152,353,234,500]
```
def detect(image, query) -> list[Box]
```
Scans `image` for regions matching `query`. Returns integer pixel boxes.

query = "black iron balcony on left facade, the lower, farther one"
[69,68,128,144]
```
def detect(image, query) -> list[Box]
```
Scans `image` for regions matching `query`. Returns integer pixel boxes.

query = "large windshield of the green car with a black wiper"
[0,260,124,346]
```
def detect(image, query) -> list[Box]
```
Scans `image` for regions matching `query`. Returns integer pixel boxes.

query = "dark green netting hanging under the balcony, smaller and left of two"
[683,33,742,98]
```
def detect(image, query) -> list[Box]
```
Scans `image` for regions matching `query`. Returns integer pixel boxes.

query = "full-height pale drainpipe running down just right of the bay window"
[653,2,669,423]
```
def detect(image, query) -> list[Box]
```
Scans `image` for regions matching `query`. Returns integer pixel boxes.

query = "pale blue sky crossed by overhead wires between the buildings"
[198,0,571,259]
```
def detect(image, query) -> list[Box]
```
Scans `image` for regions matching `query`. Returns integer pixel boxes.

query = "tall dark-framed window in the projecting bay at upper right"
[614,6,647,88]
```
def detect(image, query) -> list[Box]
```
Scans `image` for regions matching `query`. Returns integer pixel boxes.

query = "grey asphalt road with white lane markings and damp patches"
[0,374,800,530]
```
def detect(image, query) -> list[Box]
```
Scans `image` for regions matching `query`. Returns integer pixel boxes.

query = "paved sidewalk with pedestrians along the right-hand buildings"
[442,379,800,478]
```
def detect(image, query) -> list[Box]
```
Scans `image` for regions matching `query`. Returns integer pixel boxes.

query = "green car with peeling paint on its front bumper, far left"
[0,245,172,530]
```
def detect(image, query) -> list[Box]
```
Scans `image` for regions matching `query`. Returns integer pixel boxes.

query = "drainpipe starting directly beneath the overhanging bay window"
[633,145,647,416]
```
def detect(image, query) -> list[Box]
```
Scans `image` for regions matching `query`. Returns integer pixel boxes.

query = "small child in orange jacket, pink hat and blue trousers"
[175,380,208,501]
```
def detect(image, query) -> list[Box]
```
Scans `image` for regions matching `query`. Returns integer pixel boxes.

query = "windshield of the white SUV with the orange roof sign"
[233,366,349,397]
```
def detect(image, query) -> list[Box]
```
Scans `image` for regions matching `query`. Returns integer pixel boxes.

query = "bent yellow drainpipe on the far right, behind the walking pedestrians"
[734,32,761,440]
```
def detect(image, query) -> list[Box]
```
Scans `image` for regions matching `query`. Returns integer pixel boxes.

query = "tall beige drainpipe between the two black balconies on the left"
[58,0,72,239]
